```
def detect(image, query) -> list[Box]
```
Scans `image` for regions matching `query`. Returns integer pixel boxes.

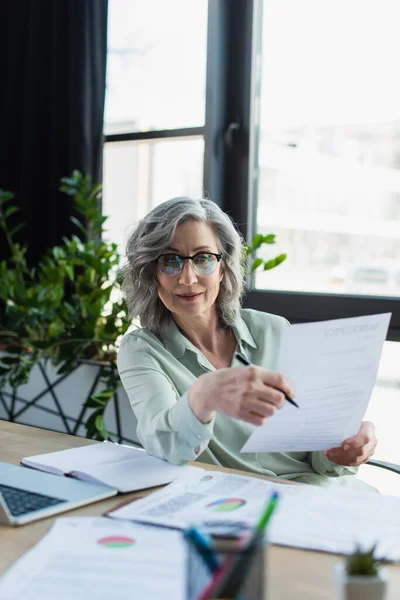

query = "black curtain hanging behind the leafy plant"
[0,0,108,264]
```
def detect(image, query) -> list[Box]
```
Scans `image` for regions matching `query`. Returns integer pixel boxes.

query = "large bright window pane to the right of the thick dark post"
[255,0,400,324]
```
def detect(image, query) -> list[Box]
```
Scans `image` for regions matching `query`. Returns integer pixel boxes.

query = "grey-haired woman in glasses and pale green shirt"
[118,198,376,486]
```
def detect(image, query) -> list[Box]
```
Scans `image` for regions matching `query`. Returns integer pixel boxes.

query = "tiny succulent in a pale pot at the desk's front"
[335,544,387,600]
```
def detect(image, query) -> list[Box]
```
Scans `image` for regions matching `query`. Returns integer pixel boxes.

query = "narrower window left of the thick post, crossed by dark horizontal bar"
[103,0,208,249]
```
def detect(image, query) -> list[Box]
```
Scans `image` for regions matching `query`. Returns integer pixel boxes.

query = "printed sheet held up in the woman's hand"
[241,313,391,452]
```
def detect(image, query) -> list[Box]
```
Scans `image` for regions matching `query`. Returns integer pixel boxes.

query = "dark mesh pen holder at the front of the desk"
[187,538,267,600]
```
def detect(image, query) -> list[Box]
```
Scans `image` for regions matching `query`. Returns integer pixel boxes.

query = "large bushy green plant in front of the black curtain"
[0,171,130,439]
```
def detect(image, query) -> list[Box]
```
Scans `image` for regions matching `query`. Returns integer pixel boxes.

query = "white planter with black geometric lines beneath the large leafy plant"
[0,361,138,443]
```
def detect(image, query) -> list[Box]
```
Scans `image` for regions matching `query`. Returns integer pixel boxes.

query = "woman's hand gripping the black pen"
[189,365,295,425]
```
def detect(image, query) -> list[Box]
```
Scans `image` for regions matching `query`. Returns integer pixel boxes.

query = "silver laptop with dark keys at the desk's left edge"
[0,462,118,525]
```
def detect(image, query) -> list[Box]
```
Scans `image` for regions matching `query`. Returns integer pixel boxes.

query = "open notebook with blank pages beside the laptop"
[21,442,199,493]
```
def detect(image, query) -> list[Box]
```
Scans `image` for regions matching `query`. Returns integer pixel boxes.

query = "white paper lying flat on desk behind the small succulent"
[268,475,400,561]
